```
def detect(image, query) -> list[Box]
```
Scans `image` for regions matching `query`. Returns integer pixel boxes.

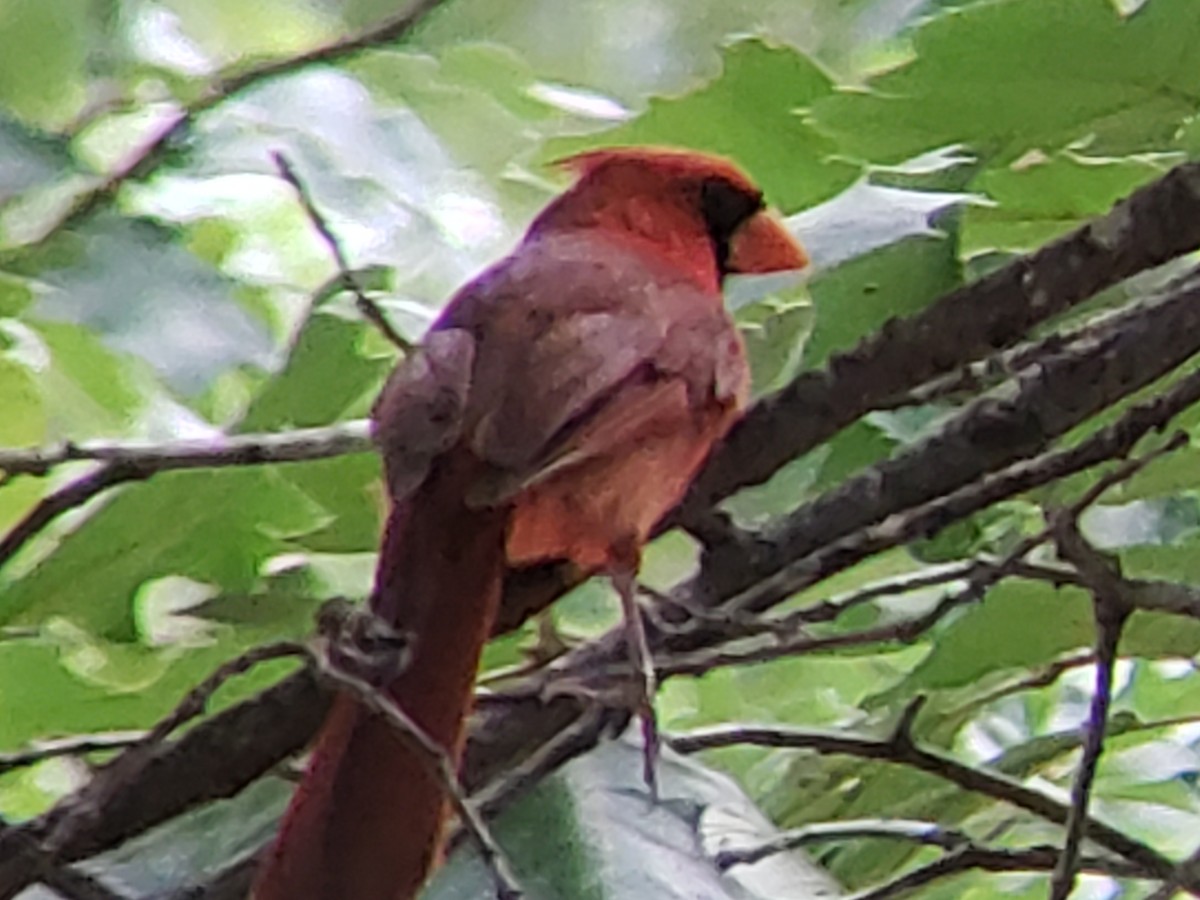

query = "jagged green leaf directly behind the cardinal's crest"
[546,41,859,211]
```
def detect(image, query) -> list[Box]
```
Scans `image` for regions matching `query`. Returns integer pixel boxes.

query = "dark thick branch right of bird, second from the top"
[695,272,1200,628]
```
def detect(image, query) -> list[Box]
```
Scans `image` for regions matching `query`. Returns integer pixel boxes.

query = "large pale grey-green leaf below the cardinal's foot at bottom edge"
[421,740,835,900]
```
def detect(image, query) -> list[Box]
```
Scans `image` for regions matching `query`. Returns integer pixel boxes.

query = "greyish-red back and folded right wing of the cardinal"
[439,235,743,503]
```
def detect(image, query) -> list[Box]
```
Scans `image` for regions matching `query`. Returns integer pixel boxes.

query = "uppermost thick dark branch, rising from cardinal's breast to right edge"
[678,163,1200,522]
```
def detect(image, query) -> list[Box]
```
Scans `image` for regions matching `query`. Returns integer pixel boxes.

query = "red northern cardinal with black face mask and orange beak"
[254,148,806,900]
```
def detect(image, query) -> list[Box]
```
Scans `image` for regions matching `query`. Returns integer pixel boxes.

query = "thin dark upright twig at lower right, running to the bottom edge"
[1050,518,1133,900]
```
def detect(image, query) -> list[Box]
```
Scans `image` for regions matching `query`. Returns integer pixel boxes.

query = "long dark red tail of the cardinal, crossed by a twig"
[252,458,505,900]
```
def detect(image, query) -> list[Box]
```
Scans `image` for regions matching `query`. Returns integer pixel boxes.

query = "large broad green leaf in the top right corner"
[814,0,1200,162]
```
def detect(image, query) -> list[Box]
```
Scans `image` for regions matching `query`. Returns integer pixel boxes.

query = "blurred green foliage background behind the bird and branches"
[0,0,1200,898]
